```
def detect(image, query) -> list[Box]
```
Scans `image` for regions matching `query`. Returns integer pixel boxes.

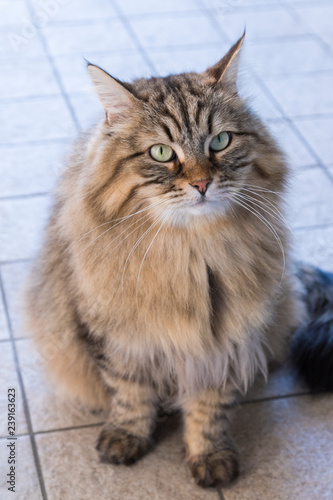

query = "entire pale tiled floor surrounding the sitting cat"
[0,0,333,500]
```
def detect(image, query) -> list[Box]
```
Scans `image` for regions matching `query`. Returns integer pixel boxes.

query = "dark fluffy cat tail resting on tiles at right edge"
[292,265,333,391]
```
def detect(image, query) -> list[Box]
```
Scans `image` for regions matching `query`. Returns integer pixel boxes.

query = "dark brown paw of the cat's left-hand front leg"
[96,424,150,465]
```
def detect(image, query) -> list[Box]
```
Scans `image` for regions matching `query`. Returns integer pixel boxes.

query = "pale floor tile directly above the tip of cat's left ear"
[43,19,135,57]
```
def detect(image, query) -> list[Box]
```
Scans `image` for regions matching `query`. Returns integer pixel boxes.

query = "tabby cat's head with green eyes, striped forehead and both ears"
[88,35,286,228]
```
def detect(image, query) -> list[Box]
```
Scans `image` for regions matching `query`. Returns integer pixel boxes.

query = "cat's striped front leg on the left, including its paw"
[96,373,156,465]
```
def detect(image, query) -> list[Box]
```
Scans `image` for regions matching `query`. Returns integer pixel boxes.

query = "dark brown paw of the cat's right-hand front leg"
[188,448,239,488]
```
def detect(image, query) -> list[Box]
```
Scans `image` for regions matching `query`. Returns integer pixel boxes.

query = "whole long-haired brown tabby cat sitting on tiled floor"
[27,36,333,486]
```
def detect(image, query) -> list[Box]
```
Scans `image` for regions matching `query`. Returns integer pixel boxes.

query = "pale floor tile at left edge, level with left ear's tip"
[0,60,60,99]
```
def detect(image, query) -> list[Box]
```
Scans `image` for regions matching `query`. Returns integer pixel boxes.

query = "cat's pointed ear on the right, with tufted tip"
[203,31,245,86]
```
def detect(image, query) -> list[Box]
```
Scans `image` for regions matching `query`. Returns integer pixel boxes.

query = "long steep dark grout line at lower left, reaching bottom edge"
[0,272,47,500]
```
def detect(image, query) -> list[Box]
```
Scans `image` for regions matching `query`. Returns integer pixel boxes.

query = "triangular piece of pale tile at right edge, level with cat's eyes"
[293,116,333,163]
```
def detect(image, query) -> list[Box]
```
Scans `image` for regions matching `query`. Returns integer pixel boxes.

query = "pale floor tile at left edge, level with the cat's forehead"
[0,96,76,145]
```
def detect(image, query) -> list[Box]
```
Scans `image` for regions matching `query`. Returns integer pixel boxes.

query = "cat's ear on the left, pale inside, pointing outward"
[87,62,139,123]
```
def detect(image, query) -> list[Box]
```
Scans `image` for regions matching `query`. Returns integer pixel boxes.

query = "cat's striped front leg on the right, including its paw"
[183,388,238,487]
